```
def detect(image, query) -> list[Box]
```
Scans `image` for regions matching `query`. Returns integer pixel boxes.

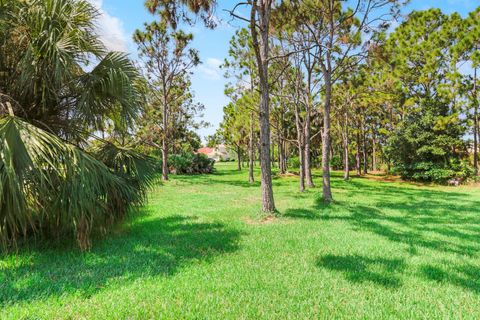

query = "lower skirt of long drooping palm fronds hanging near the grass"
[0,116,143,249]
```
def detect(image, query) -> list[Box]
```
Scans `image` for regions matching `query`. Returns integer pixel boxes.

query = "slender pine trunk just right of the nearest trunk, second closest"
[322,72,333,203]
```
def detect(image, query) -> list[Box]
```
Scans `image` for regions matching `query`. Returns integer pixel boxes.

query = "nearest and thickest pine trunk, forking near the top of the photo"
[250,0,275,213]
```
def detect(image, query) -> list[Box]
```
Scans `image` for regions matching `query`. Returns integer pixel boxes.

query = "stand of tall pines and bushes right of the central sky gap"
[148,0,480,212]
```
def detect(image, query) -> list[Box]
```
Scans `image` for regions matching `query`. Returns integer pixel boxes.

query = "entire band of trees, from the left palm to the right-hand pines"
[0,0,480,249]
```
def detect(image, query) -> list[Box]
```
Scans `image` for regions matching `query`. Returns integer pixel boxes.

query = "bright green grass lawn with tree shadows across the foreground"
[0,164,480,319]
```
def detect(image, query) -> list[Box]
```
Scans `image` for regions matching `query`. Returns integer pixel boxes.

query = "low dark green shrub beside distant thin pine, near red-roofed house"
[168,153,215,174]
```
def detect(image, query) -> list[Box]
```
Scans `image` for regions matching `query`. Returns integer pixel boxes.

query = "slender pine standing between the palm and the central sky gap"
[134,22,200,180]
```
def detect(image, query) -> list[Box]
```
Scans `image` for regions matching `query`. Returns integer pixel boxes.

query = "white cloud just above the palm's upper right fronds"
[88,0,128,52]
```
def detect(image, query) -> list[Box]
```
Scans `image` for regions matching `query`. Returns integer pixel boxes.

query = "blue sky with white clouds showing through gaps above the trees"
[89,0,480,142]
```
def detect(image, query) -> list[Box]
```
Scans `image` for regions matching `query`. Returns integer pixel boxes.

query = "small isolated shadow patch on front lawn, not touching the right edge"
[317,254,405,289]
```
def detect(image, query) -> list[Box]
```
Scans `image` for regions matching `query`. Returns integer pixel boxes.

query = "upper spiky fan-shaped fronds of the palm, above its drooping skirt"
[0,0,142,137]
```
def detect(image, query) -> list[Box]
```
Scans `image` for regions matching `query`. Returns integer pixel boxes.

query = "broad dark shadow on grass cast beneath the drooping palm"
[0,216,240,306]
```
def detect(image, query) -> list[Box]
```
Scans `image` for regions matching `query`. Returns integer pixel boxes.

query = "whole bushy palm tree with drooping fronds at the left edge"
[0,0,153,249]
